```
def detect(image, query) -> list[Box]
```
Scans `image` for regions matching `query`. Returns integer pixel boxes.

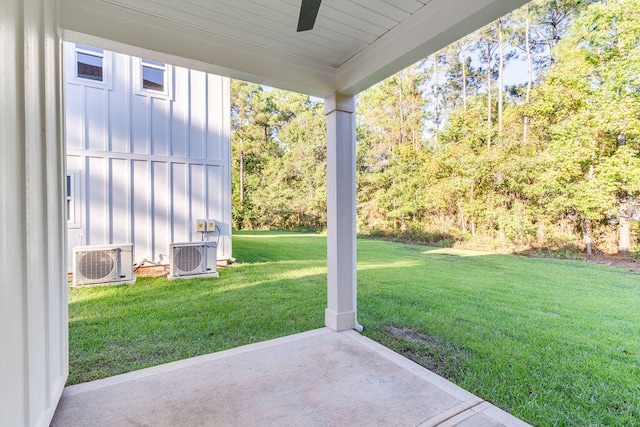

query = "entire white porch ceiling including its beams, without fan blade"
[59,0,527,96]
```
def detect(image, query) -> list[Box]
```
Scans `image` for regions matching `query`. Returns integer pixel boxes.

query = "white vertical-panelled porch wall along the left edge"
[0,0,69,426]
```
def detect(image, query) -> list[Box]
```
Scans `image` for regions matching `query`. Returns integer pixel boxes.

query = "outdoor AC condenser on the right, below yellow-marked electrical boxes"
[169,242,220,279]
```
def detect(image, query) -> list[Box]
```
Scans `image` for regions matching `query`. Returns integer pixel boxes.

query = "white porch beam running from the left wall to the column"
[58,0,337,97]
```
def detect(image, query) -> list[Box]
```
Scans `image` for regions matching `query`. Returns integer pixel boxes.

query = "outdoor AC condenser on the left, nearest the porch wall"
[73,243,136,286]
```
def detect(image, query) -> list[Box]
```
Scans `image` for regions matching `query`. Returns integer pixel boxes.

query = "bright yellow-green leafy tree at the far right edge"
[533,0,640,252]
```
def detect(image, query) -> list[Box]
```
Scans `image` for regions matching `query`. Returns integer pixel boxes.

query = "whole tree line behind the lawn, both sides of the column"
[232,0,640,254]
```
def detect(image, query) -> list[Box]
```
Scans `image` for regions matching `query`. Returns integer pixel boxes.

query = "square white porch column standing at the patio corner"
[324,93,357,331]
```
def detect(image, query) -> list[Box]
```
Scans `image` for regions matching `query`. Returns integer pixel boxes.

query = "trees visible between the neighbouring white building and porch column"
[232,80,326,230]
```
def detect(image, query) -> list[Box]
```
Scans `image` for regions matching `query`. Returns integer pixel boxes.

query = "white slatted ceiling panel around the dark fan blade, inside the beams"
[100,0,431,67]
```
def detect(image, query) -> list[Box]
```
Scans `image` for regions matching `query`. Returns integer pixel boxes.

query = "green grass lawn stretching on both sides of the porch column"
[69,232,640,426]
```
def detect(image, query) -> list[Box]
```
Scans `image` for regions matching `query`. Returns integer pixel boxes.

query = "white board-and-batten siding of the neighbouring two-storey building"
[64,42,231,269]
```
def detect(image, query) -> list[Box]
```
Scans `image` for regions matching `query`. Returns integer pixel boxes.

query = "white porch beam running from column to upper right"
[337,0,528,94]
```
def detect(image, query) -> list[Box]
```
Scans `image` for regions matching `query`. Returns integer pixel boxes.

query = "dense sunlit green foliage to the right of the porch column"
[359,0,640,254]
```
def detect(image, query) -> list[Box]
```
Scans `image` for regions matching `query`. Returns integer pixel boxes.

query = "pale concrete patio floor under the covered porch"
[51,328,528,427]
